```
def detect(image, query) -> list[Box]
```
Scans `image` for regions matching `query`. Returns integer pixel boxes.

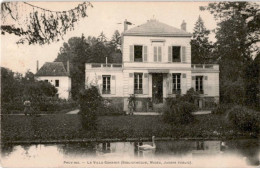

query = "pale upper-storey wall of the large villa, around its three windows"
[123,36,191,68]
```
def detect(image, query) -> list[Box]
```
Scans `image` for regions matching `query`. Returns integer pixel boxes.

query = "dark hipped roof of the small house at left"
[35,62,69,76]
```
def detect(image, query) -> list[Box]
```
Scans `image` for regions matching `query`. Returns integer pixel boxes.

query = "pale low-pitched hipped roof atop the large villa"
[123,20,192,37]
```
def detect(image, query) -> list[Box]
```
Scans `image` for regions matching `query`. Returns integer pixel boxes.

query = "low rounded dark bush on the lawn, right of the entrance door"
[163,99,196,124]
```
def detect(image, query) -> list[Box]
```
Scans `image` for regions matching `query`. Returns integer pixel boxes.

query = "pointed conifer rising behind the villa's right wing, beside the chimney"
[191,16,212,64]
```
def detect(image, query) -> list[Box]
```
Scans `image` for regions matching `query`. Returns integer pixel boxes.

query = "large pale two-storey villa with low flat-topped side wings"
[86,20,219,112]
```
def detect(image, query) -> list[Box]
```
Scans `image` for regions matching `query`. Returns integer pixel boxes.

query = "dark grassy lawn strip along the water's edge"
[1,114,256,143]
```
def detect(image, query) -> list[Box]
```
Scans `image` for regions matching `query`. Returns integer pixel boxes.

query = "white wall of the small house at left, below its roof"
[37,76,71,99]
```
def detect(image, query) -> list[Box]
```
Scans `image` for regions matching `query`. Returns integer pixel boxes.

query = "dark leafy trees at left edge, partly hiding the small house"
[1,67,57,113]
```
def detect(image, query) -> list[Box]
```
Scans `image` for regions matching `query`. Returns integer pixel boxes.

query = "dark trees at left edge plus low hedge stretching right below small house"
[1,67,77,114]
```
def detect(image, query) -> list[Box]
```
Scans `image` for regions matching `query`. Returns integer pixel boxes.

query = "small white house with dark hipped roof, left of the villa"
[35,62,71,99]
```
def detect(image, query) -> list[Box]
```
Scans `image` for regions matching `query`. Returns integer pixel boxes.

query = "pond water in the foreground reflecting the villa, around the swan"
[1,139,260,167]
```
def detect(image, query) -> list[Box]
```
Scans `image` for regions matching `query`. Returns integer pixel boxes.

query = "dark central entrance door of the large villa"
[152,74,163,103]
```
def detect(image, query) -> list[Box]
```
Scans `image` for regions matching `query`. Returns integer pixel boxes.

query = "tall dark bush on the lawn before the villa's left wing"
[79,86,103,130]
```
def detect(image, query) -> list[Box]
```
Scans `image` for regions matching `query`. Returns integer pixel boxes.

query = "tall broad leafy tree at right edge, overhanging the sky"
[201,2,260,104]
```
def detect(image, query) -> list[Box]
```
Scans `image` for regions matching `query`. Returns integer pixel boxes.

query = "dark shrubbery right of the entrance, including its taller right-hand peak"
[163,89,197,124]
